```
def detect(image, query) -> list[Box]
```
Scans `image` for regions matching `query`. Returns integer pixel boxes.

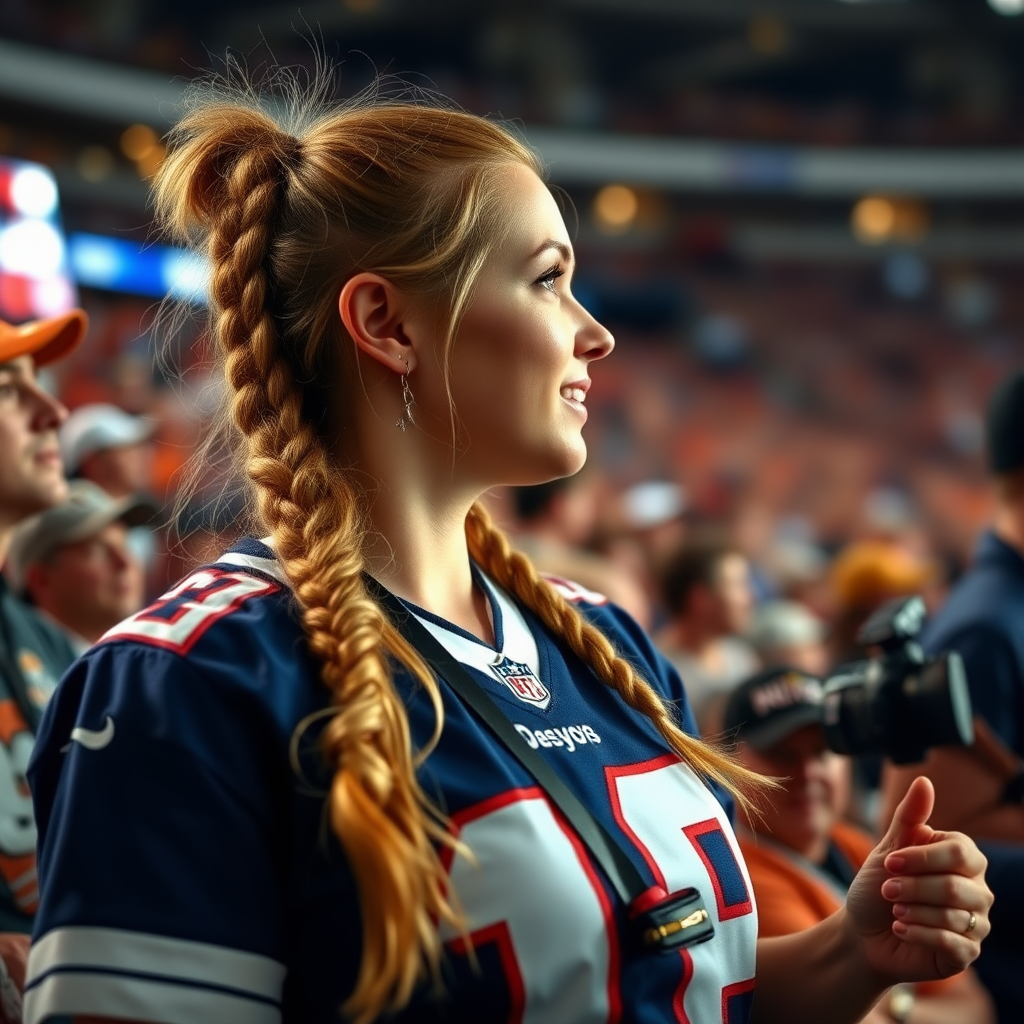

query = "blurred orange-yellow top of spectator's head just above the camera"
[829,541,939,664]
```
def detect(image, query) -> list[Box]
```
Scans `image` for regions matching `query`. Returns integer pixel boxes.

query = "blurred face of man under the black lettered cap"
[738,725,850,862]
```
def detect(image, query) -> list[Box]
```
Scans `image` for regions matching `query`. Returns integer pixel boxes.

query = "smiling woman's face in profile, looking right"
[413,165,614,486]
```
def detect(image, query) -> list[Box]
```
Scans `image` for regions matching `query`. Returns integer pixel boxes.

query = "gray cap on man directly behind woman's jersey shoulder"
[6,480,158,593]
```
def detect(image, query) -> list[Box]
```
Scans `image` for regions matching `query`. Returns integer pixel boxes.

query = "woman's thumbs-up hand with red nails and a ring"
[846,776,992,984]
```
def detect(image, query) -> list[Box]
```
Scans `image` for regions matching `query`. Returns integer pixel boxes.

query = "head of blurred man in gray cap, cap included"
[7,480,157,653]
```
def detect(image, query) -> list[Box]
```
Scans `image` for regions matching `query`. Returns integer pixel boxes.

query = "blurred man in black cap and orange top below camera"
[725,667,994,1024]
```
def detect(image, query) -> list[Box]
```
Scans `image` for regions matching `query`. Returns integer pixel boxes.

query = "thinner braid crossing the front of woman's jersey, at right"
[466,502,771,808]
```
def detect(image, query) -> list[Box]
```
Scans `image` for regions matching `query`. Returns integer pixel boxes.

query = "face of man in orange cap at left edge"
[0,355,68,531]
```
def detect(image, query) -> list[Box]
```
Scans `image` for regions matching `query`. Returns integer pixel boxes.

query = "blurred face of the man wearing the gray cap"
[26,522,144,642]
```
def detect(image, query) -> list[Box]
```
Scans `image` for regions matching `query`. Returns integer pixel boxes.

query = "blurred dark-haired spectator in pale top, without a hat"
[657,538,759,735]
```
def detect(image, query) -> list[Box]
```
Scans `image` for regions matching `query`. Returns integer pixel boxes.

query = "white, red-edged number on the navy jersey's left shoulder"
[99,569,281,654]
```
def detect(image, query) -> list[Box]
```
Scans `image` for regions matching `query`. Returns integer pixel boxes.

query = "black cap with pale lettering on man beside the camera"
[725,665,821,752]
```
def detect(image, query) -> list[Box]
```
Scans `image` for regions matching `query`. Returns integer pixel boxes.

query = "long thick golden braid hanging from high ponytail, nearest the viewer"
[156,104,459,1024]
